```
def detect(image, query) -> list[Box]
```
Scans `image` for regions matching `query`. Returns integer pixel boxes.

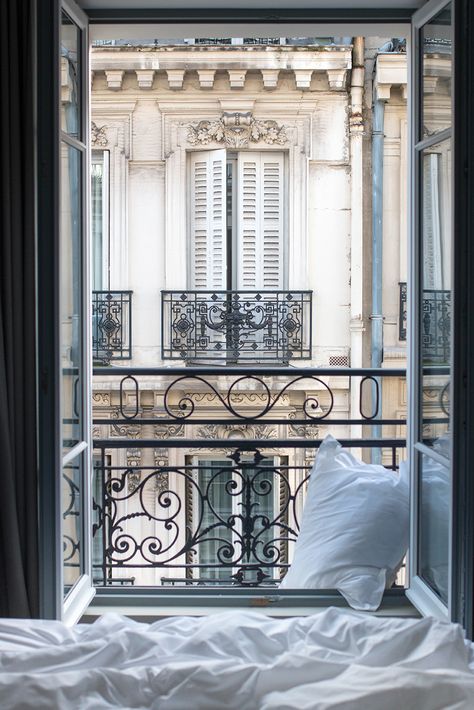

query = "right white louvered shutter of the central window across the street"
[237,152,284,290]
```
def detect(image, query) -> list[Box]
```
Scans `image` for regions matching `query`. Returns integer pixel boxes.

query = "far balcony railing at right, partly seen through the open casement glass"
[399,283,451,364]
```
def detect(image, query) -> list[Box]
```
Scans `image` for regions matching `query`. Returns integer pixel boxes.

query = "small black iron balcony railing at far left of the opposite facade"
[92,291,132,364]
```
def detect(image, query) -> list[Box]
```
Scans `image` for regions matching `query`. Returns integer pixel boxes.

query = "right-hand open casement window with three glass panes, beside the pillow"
[407,0,454,618]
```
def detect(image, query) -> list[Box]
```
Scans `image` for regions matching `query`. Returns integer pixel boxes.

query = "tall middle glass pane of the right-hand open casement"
[420,140,451,455]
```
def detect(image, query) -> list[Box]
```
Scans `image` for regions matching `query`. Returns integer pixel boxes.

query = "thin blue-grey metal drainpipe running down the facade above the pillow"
[370,93,385,463]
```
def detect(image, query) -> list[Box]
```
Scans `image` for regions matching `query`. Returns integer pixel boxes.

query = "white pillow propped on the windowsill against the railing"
[280,435,409,611]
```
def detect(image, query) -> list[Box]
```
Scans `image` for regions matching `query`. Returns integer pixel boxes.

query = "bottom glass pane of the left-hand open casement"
[61,455,83,595]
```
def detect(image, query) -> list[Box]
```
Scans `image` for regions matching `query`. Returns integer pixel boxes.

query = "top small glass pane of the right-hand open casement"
[421,4,453,138]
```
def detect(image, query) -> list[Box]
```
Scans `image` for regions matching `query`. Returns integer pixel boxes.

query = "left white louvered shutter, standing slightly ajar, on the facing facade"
[190,150,226,291]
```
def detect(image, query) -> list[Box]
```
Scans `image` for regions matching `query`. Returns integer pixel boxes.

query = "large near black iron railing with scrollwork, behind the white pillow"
[93,367,412,586]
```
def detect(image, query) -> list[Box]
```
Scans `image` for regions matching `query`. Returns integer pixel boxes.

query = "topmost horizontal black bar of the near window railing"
[93,363,410,377]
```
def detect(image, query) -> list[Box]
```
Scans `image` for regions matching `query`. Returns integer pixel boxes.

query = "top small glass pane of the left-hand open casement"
[61,12,81,139]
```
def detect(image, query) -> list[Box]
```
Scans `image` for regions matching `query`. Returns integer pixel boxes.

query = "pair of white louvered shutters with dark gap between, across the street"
[189,150,285,291]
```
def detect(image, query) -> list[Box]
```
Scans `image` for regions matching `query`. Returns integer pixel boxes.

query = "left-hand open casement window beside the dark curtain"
[39,0,94,623]
